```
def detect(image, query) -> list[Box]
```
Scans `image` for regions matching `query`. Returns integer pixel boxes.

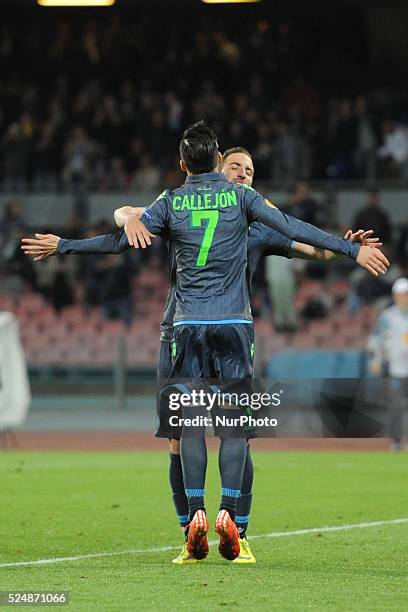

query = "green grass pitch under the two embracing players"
[0,451,408,612]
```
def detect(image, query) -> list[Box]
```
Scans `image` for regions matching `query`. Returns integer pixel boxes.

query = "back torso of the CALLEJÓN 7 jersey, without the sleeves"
[144,173,251,321]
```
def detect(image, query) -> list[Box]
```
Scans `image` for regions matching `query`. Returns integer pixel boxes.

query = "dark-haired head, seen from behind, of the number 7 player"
[179,121,218,174]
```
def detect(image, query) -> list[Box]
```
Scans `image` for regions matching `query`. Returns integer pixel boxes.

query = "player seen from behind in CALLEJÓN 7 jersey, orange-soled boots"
[141,124,366,560]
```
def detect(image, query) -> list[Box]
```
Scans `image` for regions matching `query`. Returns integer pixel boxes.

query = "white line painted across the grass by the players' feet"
[0,517,408,568]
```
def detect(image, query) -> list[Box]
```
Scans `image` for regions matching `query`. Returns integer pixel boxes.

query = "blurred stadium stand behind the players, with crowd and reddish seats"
[0,7,408,367]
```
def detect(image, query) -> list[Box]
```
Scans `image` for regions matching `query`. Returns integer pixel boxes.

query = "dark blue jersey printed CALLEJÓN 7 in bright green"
[141,173,360,325]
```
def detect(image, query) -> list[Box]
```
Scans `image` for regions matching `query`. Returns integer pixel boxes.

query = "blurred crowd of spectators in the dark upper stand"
[0,13,408,191]
